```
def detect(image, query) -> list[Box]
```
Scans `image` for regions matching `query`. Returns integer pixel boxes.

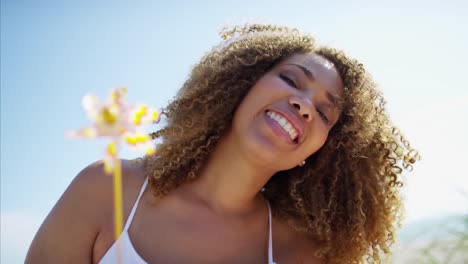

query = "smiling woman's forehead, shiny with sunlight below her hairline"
[278,53,344,96]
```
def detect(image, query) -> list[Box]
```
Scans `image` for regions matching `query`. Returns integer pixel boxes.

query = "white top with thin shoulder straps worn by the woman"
[99,179,276,264]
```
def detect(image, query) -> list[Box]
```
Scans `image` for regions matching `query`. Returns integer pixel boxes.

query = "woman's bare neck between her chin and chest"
[181,133,274,215]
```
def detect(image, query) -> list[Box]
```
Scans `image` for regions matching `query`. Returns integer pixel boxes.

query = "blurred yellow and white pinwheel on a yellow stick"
[67,88,159,259]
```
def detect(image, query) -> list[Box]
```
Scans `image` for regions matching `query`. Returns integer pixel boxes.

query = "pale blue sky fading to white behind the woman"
[0,0,468,263]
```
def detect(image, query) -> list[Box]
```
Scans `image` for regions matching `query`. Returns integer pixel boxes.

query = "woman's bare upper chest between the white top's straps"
[97,200,278,263]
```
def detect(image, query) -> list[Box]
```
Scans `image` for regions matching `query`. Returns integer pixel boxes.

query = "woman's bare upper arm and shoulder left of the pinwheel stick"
[25,162,112,263]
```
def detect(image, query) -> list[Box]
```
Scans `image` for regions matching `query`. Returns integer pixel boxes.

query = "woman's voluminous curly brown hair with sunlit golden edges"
[143,24,419,263]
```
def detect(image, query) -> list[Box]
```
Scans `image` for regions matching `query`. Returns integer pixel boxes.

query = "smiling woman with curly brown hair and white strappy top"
[26,25,418,263]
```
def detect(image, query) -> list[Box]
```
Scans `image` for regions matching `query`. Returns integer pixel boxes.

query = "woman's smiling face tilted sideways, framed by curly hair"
[230,54,344,171]
